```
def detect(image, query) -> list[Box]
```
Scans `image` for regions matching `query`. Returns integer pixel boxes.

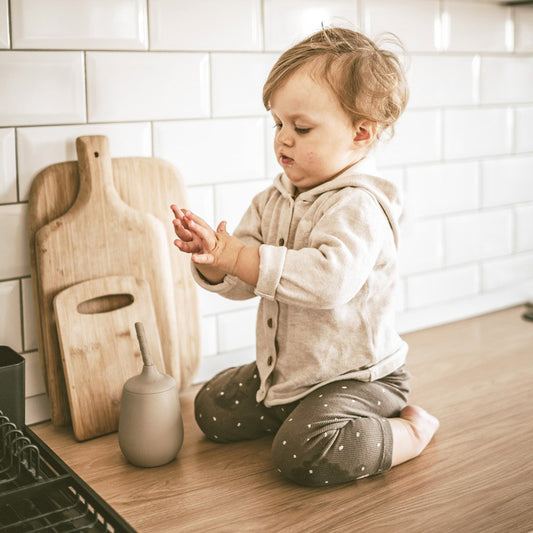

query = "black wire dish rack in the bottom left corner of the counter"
[0,411,135,533]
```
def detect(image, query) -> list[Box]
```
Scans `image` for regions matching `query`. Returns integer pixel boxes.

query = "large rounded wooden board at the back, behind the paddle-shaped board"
[28,137,200,424]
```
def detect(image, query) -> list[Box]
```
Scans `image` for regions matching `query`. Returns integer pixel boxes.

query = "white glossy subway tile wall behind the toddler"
[0,0,533,423]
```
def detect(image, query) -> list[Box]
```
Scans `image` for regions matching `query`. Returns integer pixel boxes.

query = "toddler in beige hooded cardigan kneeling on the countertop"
[172,28,438,486]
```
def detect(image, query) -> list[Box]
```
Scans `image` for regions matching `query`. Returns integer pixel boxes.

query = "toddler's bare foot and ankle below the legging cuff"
[389,405,439,466]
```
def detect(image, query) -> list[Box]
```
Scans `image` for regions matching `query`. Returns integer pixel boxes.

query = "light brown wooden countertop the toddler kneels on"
[33,308,533,533]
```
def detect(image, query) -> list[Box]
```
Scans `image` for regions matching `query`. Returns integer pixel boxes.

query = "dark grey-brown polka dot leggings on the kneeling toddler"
[195,363,410,486]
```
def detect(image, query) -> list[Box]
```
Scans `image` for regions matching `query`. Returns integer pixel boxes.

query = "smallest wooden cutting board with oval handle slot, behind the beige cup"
[54,276,164,441]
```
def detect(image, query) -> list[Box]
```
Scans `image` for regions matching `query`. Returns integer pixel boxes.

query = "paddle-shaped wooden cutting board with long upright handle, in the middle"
[35,136,179,423]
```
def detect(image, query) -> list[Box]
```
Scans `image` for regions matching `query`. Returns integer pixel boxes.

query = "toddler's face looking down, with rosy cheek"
[270,68,364,191]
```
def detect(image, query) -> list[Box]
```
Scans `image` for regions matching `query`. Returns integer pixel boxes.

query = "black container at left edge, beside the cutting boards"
[0,346,26,428]
